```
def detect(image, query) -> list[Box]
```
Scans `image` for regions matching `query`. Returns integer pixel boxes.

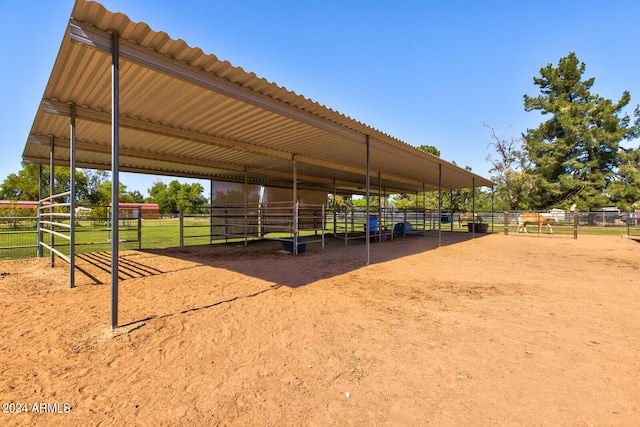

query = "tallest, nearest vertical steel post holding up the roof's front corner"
[111,33,120,330]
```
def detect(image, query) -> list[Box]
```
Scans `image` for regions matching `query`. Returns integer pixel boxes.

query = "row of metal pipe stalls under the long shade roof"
[179,202,494,254]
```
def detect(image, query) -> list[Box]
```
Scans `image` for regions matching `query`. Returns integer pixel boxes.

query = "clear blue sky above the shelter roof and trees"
[0,0,640,194]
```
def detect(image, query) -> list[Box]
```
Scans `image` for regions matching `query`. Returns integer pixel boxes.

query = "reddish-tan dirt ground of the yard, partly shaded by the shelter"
[0,233,640,426]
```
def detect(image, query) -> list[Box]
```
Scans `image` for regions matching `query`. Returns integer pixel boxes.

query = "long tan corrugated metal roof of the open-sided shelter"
[23,0,492,194]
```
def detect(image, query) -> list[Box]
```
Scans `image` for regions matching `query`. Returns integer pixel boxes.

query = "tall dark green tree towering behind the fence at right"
[524,52,636,209]
